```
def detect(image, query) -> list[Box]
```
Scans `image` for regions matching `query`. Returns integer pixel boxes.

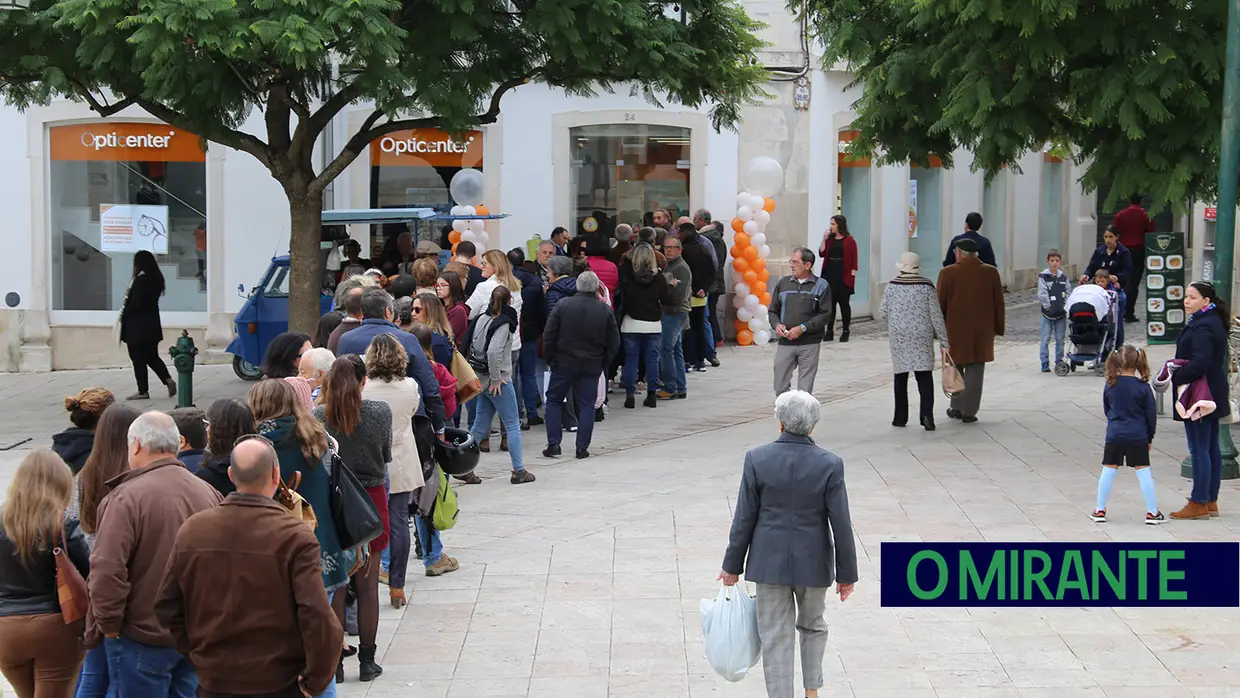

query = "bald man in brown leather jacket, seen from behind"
[156,436,343,698]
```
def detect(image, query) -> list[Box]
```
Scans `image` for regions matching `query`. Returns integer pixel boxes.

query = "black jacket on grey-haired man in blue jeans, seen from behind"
[543,291,620,373]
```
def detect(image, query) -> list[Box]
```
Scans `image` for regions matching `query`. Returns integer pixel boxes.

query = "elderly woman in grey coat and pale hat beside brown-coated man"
[879,252,949,431]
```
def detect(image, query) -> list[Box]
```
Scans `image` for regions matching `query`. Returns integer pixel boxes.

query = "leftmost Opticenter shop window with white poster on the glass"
[48,123,207,312]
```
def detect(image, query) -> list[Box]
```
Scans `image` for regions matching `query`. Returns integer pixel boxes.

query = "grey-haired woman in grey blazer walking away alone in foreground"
[719,391,857,698]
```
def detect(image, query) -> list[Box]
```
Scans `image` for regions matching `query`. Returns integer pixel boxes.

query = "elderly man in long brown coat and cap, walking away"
[939,238,1004,424]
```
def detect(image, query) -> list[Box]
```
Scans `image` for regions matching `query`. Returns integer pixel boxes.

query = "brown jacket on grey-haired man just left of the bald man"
[86,456,221,647]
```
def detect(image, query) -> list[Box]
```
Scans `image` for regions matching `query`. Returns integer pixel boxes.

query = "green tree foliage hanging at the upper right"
[792,0,1228,209]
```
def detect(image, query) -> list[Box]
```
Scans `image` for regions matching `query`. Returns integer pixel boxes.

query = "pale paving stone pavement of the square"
[0,329,1240,698]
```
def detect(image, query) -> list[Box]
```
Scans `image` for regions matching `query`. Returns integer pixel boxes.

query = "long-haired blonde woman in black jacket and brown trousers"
[0,449,91,698]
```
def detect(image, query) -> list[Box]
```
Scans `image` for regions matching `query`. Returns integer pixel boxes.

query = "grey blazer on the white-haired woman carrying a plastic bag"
[723,434,857,586]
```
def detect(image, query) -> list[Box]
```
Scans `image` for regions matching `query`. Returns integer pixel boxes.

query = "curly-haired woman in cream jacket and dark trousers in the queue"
[362,335,425,609]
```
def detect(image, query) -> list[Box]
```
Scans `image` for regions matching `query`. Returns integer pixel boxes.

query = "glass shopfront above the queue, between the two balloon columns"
[569,124,692,234]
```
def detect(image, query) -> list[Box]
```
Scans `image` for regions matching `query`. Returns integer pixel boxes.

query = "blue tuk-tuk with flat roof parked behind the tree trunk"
[227,208,507,381]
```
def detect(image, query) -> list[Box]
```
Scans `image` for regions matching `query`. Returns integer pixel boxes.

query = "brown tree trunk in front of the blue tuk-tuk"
[286,188,322,336]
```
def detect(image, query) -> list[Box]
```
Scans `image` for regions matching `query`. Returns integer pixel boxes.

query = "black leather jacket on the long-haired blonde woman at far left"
[0,519,91,616]
